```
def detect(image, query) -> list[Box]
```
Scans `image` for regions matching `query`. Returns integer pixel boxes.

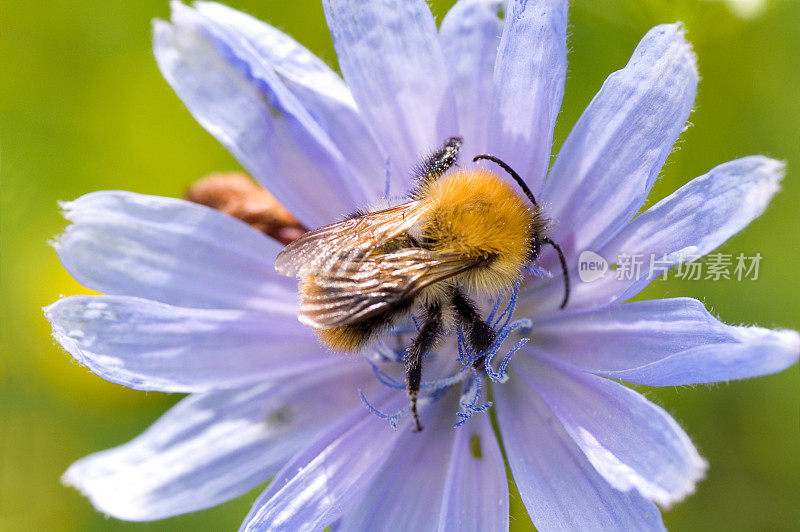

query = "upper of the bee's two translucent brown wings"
[275,201,422,276]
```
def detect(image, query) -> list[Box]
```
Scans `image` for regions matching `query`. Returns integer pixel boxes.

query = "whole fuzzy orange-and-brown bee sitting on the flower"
[275,137,569,432]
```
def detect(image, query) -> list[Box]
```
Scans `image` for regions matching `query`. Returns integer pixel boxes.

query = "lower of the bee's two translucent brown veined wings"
[298,248,480,329]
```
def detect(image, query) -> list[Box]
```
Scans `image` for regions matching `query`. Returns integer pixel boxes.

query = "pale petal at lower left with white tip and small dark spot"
[63,368,371,521]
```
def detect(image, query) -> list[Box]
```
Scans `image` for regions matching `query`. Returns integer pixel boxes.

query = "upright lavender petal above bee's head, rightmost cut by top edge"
[489,0,567,198]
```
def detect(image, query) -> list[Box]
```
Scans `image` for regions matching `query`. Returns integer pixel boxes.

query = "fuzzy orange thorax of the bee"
[417,169,543,293]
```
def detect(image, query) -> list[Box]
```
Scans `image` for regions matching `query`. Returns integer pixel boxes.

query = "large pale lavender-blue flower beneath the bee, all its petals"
[46,0,800,530]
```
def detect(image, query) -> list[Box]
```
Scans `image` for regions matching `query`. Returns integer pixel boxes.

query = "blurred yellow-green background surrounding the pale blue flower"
[0,0,800,530]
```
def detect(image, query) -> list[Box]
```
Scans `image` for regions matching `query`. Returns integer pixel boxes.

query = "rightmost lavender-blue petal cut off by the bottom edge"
[495,370,665,532]
